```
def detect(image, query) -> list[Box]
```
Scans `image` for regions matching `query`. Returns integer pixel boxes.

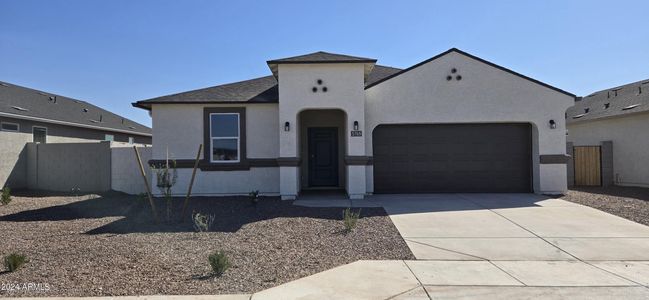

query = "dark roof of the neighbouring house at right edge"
[566,79,649,124]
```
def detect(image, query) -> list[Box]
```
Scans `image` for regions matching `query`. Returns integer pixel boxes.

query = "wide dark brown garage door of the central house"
[372,124,532,193]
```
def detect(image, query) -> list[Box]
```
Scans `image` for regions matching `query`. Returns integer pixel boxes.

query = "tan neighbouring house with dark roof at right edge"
[566,79,649,187]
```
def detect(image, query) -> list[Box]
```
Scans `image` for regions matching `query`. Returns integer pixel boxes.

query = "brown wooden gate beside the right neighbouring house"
[573,146,602,186]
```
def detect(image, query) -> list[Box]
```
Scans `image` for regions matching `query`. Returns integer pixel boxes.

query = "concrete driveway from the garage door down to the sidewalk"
[370,194,649,261]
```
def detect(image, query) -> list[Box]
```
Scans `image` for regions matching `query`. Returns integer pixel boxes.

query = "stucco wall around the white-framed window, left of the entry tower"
[152,104,280,195]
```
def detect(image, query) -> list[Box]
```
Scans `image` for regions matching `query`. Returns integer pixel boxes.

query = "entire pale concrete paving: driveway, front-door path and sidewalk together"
[280,194,649,299]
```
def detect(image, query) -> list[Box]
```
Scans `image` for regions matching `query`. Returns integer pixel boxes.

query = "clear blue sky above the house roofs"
[0,0,649,125]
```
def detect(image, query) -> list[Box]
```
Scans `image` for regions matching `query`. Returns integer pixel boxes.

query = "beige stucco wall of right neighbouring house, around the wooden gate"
[568,113,649,187]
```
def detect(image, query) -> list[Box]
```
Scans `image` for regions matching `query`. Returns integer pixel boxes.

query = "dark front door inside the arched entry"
[308,127,338,187]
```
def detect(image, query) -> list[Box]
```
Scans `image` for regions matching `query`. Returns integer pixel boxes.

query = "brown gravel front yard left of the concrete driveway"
[0,193,414,296]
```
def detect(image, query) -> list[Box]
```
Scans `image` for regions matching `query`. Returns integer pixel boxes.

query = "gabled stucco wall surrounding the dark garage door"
[364,52,574,193]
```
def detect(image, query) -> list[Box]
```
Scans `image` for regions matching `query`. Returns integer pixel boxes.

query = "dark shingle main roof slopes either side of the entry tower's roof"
[133,65,401,109]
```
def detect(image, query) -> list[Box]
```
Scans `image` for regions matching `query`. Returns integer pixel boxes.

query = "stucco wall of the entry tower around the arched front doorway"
[278,63,366,199]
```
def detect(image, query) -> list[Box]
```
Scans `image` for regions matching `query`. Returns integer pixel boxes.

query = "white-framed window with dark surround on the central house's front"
[210,113,241,163]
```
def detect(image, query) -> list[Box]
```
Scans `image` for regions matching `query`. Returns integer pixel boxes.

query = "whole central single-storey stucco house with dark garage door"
[133,49,575,199]
